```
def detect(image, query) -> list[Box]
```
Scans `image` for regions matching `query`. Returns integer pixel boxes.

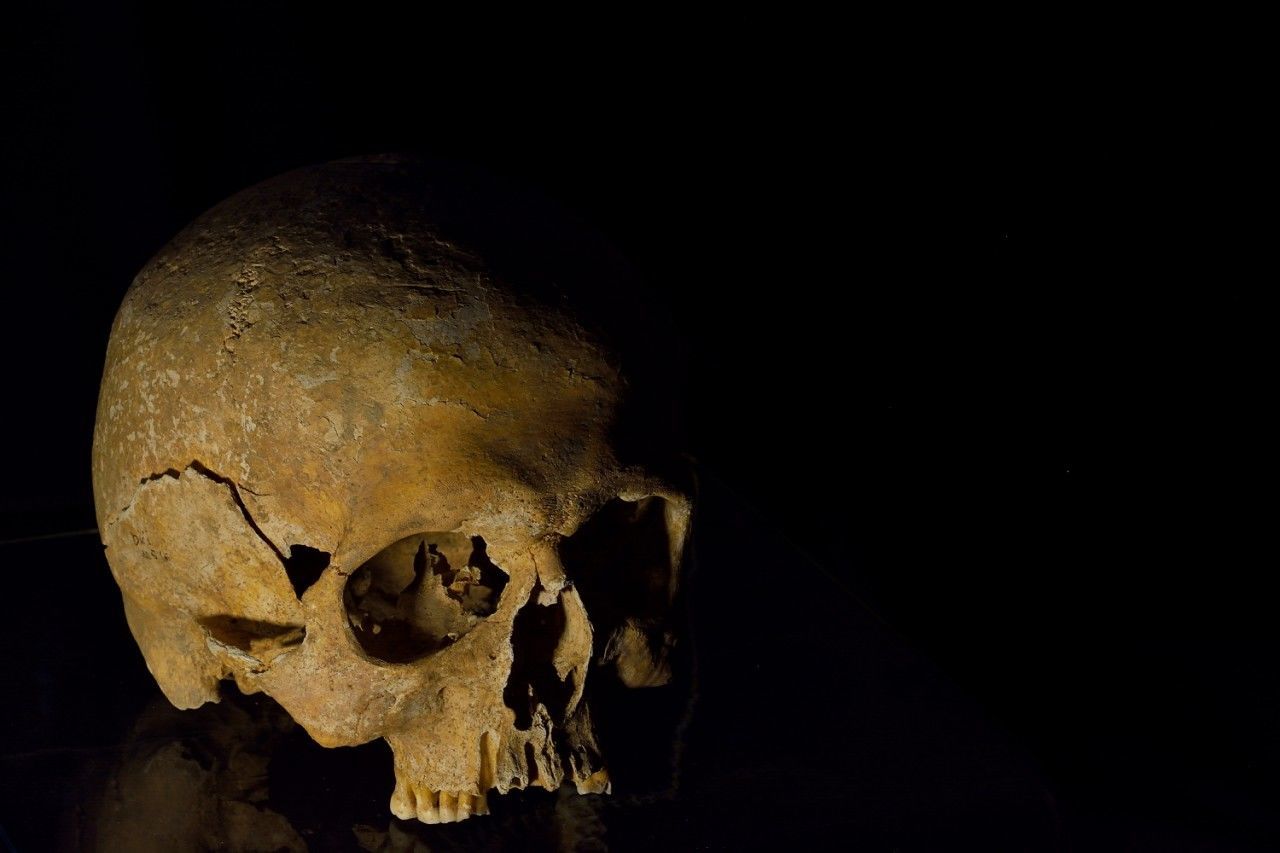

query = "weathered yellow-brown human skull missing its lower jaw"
[93,160,690,822]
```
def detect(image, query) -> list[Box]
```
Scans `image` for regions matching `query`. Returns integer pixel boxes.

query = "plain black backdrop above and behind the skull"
[0,4,1280,849]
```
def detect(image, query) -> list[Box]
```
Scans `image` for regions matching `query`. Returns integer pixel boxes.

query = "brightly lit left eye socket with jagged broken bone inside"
[343,533,507,663]
